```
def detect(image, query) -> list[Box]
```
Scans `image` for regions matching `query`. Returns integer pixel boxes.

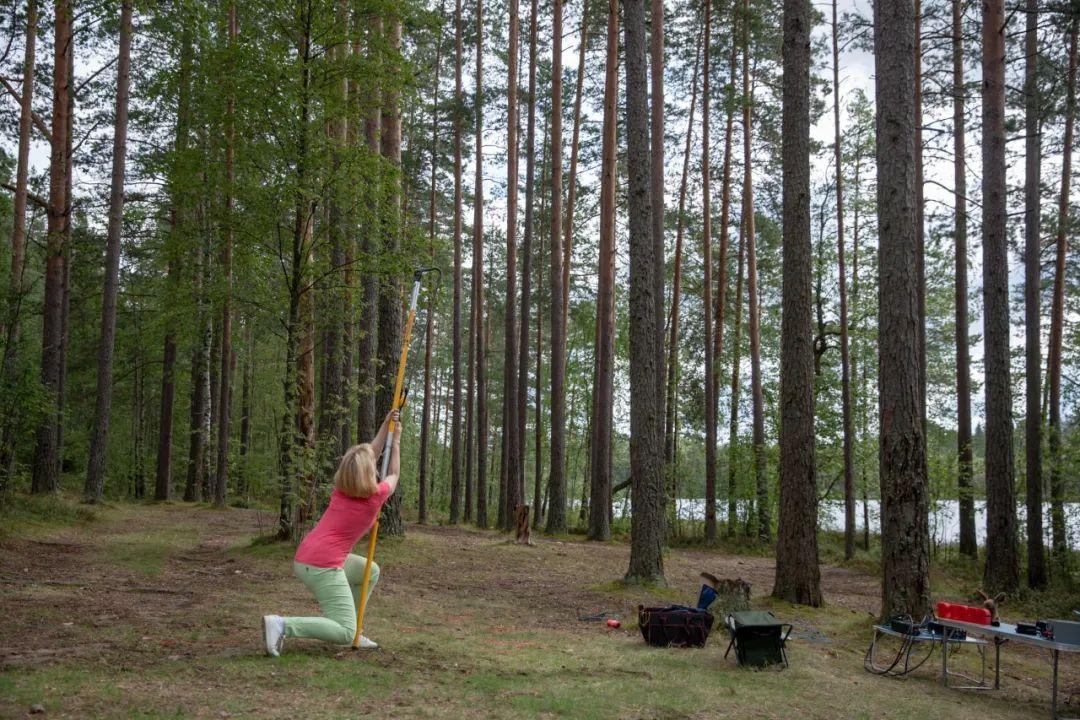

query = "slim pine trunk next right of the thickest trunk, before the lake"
[953,0,978,558]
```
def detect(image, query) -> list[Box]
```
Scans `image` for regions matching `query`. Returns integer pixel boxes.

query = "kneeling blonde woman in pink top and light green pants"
[262,411,401,657]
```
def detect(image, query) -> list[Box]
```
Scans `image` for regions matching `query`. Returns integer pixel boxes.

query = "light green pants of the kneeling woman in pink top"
[285,555,379,646]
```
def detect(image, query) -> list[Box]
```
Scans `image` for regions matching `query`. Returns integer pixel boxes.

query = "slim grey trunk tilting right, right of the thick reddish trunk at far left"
[83,0,132,503]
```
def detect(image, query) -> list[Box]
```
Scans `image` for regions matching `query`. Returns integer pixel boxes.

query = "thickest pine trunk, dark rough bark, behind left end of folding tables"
[874,0,930,617]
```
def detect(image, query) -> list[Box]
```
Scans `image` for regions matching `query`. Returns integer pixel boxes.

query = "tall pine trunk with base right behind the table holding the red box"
[983,0,1020,593]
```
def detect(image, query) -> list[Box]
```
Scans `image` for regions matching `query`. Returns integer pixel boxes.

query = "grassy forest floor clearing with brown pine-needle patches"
[0,504,1080,720]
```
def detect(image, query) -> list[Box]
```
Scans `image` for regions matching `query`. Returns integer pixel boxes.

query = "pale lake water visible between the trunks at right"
[615,498,1080,549]
